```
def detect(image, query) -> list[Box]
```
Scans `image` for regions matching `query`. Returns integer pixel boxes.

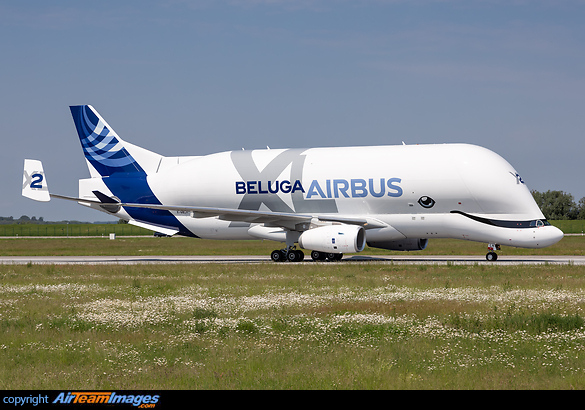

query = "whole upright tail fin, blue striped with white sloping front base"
[69,105,162,177]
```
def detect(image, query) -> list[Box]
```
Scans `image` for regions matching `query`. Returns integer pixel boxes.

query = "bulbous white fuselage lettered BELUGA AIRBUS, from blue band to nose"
[114,144,562,248]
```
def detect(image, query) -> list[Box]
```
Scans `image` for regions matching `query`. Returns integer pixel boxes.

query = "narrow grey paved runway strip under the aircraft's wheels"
[0,255,585,265]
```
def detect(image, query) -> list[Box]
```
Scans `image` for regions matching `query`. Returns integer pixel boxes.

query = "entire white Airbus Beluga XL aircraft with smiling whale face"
[22,105,563,262]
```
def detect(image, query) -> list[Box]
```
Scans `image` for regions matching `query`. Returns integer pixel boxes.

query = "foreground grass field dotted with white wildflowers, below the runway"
[0,262,585,390]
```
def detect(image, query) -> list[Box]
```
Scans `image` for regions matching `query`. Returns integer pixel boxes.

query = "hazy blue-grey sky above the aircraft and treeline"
[0,0,585,221]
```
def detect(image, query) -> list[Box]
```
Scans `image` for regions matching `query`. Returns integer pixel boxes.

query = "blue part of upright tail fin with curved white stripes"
[69,105,146,177]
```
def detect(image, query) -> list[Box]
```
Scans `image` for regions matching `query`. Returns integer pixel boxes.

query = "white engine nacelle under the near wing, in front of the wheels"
[298,225,366,253]
